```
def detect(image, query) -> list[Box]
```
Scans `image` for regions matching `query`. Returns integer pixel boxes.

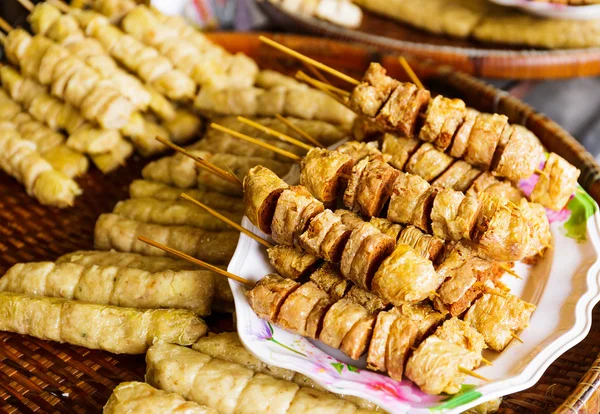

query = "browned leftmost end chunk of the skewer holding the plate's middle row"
[244,165,288,234]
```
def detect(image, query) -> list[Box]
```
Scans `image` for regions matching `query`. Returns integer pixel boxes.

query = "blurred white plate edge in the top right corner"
[490,0,600,20]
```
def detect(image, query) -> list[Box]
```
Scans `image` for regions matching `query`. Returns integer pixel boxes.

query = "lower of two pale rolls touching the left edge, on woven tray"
[0,292,207,354]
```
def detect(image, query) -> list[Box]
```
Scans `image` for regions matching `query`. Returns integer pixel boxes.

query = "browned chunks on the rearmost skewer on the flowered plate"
[349,63,579,209]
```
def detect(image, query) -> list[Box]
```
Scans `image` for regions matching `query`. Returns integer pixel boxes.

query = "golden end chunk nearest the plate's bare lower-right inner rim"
[464,290,535,351]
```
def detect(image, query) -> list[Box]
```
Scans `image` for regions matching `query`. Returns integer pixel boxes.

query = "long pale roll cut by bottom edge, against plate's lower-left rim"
[146,343,372,414]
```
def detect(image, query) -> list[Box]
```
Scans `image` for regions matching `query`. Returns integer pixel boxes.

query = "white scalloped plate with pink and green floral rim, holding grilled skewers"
[228,182,600,413]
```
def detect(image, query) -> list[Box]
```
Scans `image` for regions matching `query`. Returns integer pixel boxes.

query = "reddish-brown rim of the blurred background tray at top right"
[257,0,600,79]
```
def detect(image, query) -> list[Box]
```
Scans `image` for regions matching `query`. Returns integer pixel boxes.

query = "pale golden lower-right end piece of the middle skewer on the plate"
[372,244,443,305]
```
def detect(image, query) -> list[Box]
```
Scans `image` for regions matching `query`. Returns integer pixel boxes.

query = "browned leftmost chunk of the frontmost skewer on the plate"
[246,274,300,322]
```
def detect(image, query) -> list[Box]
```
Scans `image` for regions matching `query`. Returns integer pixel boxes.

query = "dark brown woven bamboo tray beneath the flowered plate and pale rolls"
[0,33,600,413]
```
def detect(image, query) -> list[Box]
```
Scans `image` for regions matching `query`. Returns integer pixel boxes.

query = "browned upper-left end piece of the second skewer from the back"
[300,148,353,204]
